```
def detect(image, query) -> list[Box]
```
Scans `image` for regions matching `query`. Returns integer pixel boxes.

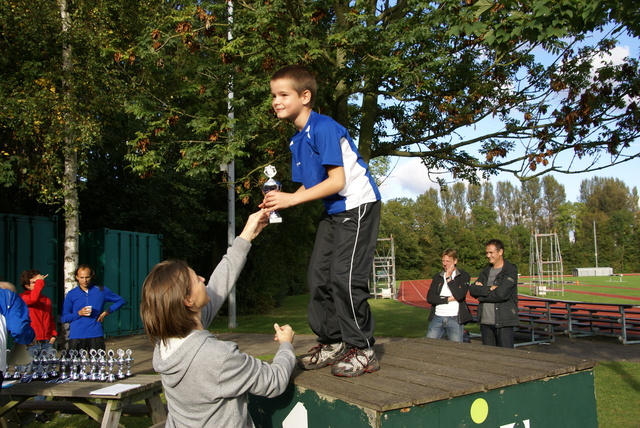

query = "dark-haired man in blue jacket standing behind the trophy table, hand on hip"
[60,265,126,350]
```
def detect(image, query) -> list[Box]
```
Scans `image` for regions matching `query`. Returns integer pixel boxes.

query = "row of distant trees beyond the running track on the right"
[380,175,640,279]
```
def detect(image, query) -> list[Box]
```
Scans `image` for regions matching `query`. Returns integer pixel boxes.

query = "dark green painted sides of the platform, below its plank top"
[249,371,598,428]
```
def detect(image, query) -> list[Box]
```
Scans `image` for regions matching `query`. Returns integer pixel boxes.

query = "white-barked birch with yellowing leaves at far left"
[0,0,105,290]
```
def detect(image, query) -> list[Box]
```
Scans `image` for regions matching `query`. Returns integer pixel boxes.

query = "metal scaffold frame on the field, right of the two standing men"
[529,231,564,296]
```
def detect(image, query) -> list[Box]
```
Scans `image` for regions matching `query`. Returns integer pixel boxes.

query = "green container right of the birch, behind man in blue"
[80,229,162,337]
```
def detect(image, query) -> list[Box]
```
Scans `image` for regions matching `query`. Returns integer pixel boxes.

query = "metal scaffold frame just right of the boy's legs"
[369,235,396,299]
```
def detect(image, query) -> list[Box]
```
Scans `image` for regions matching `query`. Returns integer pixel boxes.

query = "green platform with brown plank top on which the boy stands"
[250,339,598,428]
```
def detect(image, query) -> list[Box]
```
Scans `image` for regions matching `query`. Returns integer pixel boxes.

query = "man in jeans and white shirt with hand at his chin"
[427,249,472,342]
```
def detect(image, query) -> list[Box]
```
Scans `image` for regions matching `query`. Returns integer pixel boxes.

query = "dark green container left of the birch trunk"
[0,214,62,314]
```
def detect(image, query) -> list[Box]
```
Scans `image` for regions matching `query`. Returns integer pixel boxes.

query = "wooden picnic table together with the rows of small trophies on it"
[0,349,167,428]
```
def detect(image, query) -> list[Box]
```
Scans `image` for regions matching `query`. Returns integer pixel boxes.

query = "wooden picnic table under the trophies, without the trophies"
[0,374,167,428]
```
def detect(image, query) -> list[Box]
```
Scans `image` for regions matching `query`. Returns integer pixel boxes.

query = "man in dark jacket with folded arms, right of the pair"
[469,239,518,348]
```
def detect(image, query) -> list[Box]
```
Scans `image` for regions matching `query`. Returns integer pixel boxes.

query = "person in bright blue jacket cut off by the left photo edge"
[0,283,36,379]
